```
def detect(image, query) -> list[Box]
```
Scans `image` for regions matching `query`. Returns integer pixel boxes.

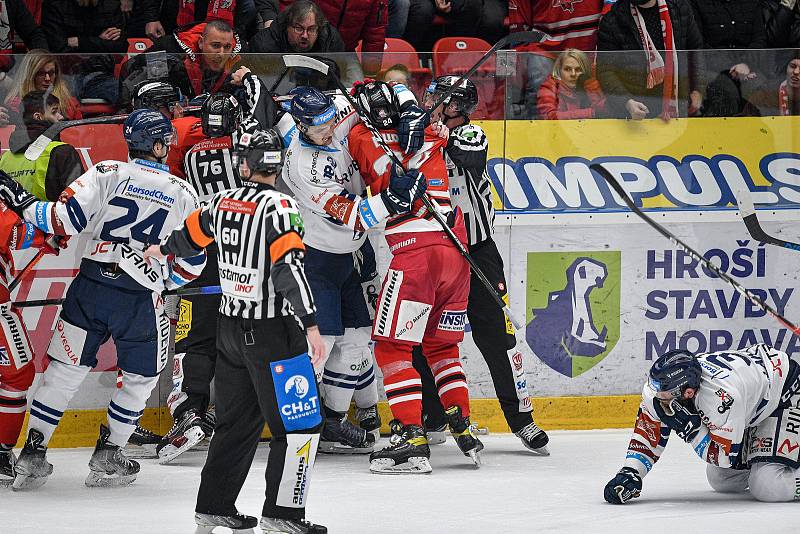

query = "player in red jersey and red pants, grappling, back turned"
[349,82,483,473]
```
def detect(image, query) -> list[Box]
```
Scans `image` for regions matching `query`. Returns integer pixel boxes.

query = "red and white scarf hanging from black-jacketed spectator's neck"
[631,0,678,120]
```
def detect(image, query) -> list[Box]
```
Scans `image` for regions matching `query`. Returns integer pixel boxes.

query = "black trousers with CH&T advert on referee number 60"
[195,315,322,519]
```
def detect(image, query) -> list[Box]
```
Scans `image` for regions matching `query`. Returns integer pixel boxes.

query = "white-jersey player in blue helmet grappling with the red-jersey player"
[282,86,424,454]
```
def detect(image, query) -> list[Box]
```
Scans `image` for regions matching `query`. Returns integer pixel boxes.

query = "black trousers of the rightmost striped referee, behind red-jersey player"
[412,239,533,432]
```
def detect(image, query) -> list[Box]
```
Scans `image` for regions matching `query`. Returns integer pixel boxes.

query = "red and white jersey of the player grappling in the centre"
[350,124,452,247]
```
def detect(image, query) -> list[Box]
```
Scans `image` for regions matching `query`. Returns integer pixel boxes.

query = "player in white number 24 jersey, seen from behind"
[0,110,205,490]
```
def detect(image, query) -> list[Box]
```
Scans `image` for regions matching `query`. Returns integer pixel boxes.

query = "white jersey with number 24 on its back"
[25,159,206,292]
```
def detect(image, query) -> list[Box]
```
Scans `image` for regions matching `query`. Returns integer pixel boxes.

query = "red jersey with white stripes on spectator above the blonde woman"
[508,0,603,52]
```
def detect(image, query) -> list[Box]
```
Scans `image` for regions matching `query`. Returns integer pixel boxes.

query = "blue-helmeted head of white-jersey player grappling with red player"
[289,87,336,146]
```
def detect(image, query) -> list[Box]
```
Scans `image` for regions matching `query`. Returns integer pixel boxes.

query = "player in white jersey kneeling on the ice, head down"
[604,344,800,504]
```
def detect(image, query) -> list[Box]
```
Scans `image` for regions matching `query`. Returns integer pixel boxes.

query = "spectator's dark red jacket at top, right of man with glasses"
[281,0,389,76]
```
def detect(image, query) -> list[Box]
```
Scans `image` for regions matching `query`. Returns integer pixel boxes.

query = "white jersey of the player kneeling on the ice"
[625,344,789,476]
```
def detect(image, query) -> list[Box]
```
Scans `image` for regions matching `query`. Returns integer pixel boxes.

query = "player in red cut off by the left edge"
[0,191,66,486]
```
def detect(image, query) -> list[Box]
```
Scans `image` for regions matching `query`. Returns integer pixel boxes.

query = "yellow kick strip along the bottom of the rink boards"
[17,395,641,447]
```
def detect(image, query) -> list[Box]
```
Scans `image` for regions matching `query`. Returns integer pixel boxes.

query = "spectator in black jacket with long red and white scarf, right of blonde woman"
[597,0,704,120]
